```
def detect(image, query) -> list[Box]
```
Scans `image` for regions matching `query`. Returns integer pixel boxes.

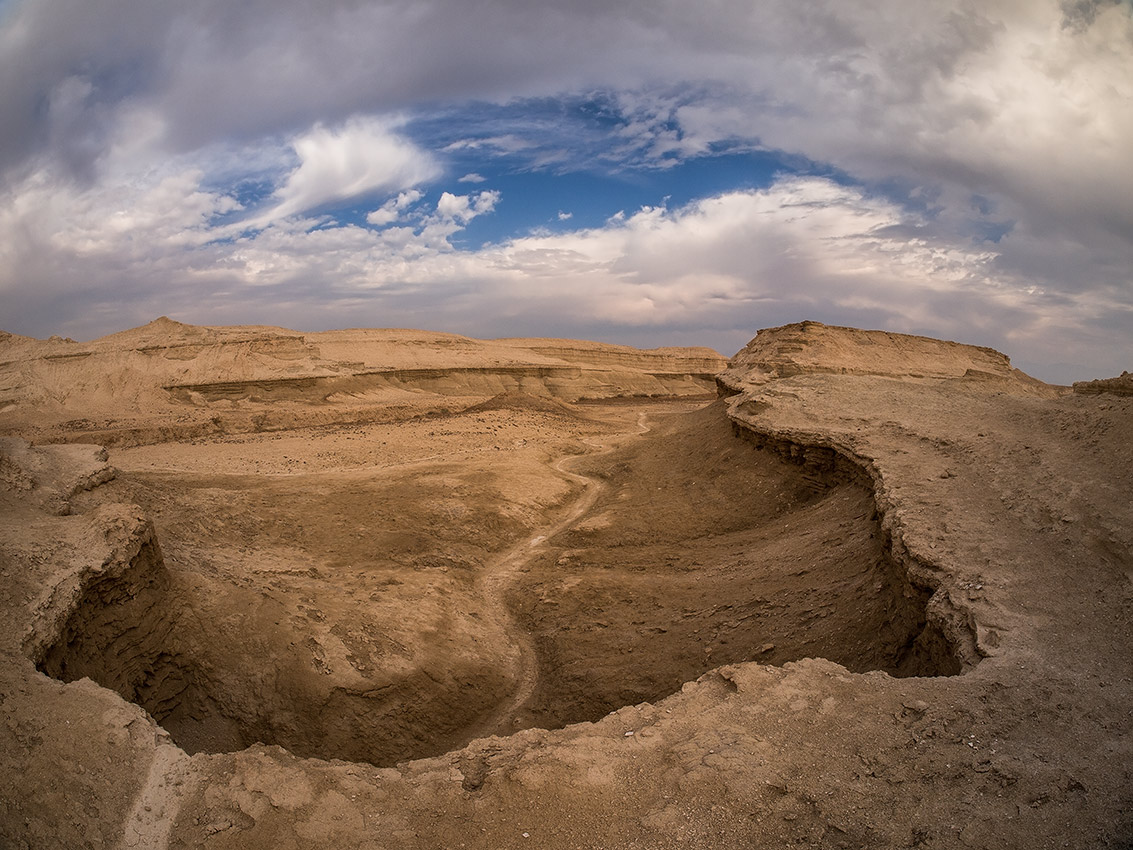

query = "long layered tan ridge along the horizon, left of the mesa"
[0,317,724,445]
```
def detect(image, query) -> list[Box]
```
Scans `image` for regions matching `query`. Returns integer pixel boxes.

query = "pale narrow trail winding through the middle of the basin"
[465,411,650,741]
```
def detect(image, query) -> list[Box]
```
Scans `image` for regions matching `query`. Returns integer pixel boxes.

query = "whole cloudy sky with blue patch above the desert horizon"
[0,0,1133,383]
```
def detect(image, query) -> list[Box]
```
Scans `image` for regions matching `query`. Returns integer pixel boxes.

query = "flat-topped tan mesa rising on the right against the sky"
[716,322,1040,394]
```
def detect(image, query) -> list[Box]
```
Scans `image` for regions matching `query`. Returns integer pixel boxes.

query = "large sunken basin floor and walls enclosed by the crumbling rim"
[37,394,960,765]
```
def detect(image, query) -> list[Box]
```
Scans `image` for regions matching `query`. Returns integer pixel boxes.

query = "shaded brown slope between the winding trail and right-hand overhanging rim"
[511,403,961,726]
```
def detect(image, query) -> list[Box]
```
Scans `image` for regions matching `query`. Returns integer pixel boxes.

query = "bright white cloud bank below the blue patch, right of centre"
[480,178,993,325]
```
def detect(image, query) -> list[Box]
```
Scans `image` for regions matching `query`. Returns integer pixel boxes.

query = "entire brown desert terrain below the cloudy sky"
[0,318,1133,850]
